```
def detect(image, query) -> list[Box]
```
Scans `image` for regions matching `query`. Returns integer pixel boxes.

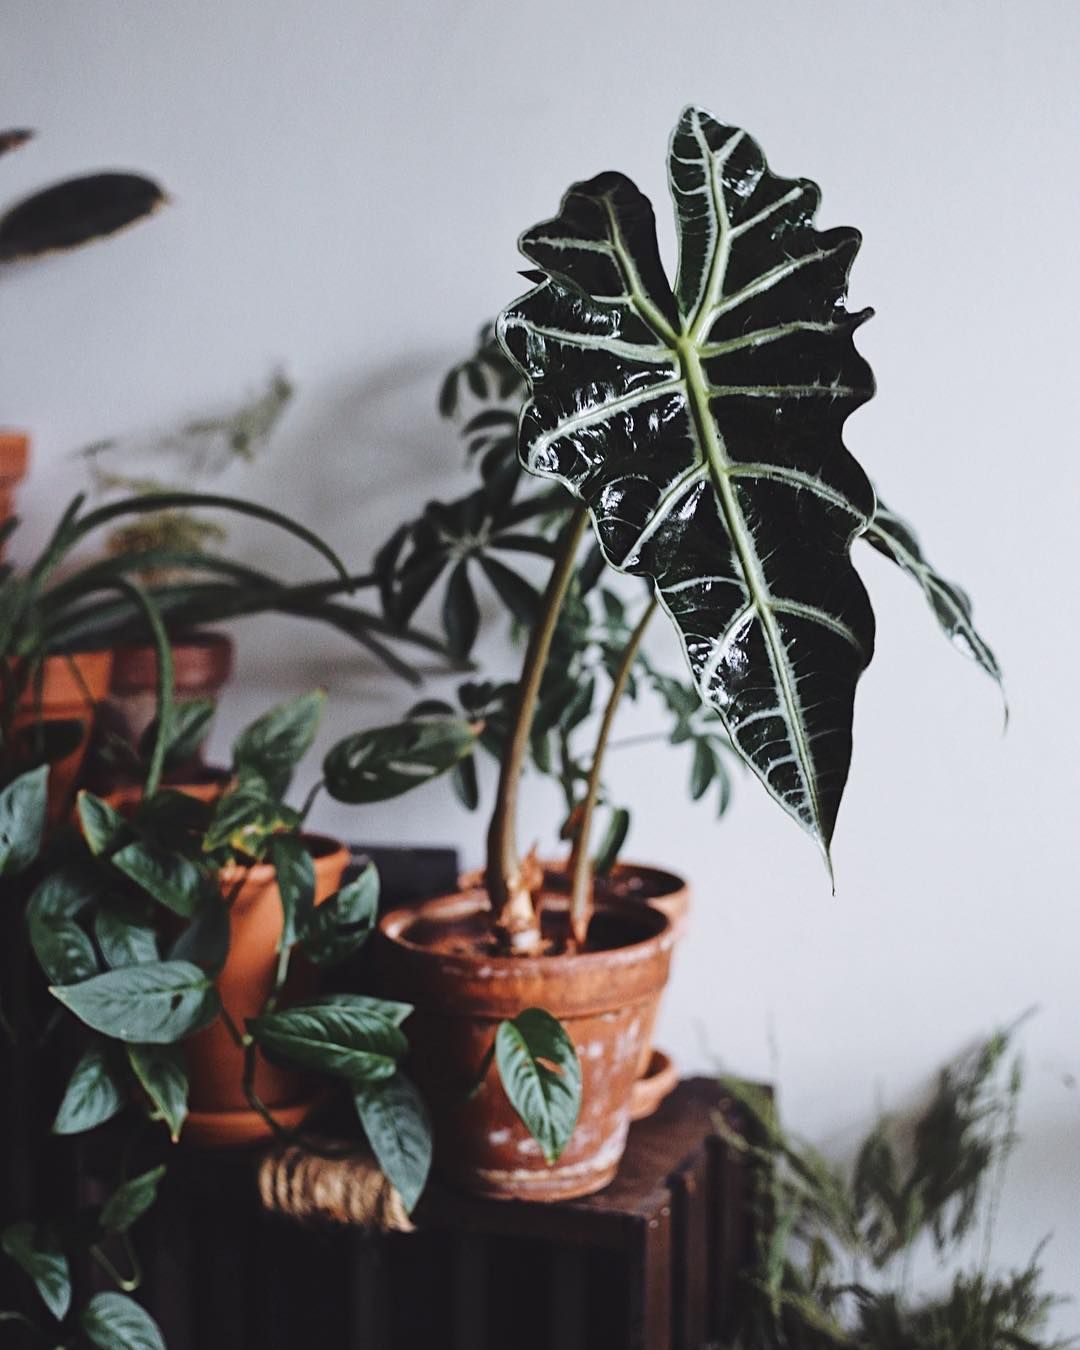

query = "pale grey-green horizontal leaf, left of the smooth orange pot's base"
[53,961,221,1045]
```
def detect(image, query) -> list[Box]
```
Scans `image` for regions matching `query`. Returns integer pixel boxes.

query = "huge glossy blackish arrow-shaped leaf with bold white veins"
[498,108,875,859]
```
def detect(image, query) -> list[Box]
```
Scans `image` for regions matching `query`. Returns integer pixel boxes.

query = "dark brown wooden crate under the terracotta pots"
[114,1079,749,1350]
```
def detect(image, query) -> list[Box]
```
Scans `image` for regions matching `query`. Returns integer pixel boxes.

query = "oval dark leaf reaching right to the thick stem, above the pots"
[323,717,477,805]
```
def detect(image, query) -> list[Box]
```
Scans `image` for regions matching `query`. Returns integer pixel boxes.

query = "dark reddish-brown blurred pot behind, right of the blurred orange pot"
[92,632,234,790]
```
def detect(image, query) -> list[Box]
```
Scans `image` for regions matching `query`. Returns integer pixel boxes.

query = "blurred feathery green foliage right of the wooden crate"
[720,1031,1073,1350]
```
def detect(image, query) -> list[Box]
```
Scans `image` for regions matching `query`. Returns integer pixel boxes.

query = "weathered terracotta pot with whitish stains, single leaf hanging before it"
[378,888,672,1200]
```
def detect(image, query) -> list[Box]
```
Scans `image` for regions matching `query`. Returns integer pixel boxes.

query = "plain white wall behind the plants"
[0,0,1080,1327]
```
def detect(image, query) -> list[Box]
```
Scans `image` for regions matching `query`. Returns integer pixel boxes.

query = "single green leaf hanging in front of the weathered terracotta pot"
[495,1008,582,1164]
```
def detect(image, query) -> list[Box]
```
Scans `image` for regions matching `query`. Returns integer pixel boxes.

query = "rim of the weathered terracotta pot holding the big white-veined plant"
[378,887,675,980]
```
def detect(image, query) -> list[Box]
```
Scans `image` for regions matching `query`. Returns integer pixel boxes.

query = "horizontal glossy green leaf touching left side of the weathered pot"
[247,1003,408,1083]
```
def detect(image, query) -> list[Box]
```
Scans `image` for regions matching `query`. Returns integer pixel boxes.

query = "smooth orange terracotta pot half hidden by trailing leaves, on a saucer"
[184,836,350,1146]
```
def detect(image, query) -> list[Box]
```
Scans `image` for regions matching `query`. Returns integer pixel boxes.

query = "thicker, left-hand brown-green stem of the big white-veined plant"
[486,504,589,952]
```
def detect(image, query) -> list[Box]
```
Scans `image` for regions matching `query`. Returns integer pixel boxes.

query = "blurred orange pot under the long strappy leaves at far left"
[12,652,112,825]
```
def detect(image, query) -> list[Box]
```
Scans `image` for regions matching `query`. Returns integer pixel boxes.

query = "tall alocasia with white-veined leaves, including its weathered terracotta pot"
[377,108,999,1199]
